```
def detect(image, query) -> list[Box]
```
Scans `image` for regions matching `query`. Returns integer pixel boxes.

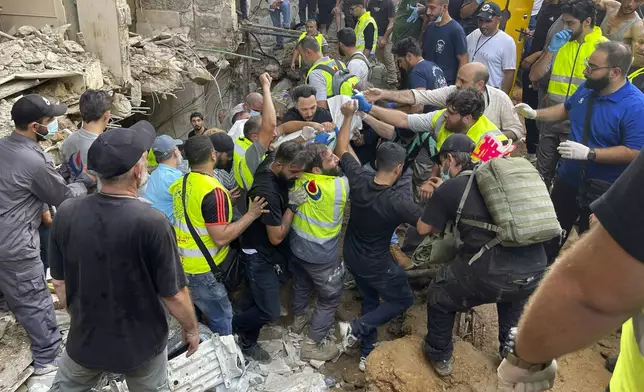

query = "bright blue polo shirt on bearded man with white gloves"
[557,81,644,186]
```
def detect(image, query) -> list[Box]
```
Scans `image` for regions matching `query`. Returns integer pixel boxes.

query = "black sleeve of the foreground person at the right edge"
[591,153,644,262]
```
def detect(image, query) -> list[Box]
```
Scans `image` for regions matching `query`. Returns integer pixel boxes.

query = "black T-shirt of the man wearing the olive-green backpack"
[421,175,546,274]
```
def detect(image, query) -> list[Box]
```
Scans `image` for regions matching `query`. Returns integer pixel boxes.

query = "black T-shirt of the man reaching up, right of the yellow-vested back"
[340,153,421,276]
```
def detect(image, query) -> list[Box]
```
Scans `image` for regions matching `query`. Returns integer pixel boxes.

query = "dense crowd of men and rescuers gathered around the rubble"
[0,0,644,392]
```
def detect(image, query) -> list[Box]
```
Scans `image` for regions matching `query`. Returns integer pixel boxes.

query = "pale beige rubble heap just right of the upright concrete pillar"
[129,32,218,95]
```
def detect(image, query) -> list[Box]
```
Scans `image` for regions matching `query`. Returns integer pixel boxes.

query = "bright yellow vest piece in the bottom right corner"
[610,310,644,392]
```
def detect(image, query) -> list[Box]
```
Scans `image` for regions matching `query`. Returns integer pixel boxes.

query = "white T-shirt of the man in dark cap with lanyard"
[467,29,517,88]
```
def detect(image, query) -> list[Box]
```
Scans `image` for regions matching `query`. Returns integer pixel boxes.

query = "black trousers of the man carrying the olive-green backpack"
[423,259,541,362]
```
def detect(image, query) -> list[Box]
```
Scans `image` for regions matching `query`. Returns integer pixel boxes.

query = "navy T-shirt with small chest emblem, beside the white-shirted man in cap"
[423,20,467,86]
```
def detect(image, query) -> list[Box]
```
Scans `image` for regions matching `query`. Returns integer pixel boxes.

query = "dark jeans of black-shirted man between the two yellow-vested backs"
[233,253,280,348]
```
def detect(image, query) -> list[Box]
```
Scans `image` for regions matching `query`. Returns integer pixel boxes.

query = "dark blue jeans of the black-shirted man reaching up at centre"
[349,261,414,358]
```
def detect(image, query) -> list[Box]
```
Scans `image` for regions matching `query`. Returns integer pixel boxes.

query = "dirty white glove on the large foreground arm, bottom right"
[496,359,557,392]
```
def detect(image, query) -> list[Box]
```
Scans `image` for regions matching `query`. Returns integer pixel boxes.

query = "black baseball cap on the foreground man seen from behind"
[87,121,157,178]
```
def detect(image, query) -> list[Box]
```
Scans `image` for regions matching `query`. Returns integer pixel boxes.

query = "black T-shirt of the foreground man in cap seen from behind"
[49,193,186,373]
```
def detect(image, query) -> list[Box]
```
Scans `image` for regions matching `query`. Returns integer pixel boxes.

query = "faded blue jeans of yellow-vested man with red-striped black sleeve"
[186,272,233,336]
